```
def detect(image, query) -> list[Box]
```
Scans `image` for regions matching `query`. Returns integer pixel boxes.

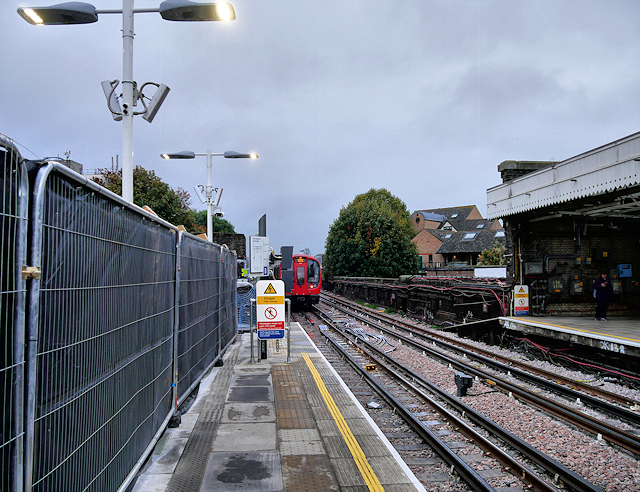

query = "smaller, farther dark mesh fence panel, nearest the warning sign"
[177,233,237,403]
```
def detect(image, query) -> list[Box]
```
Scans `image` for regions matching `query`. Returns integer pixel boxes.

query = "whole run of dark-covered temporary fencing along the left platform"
[1,152,237,492]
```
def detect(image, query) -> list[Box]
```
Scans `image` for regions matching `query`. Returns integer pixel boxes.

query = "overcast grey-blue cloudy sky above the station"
[0,0,640,254]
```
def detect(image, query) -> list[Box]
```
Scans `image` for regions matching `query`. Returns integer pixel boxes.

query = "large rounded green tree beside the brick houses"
[323,189,419,278]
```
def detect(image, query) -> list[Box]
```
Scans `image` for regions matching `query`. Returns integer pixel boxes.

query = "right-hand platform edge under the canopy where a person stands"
[499,316,640,359]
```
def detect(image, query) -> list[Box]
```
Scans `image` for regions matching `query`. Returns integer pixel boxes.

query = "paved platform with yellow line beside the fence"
[130,323,424,492]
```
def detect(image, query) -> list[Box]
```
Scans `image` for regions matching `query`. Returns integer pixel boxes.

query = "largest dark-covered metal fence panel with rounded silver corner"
[25,164,177,492]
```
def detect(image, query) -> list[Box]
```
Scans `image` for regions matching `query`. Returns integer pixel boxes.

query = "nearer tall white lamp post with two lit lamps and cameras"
[18,0,236,202]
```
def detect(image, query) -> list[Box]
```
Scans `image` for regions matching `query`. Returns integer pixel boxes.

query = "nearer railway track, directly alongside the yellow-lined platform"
[298,312,602,491]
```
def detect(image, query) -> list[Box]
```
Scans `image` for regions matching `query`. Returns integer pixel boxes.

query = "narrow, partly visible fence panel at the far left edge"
[0,135,29,490]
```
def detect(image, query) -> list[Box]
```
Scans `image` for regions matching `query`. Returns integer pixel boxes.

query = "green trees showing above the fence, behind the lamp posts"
[94,166,198,234]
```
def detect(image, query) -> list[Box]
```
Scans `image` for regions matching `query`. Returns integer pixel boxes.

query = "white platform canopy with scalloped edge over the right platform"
[487,133,640,220]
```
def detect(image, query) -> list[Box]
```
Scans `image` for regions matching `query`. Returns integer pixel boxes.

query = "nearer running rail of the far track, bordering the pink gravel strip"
[320,300,640,455]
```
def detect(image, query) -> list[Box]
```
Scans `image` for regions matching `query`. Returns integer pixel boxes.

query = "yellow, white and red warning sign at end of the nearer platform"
[256,280,285,340]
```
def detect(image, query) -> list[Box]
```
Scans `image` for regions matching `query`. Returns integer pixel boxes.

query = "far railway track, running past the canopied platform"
[325,292,640,456]
